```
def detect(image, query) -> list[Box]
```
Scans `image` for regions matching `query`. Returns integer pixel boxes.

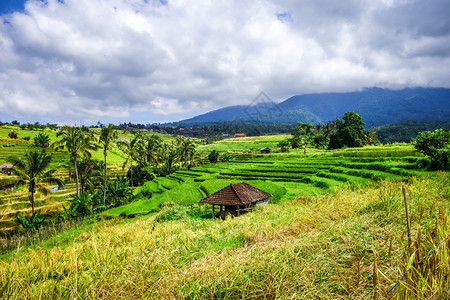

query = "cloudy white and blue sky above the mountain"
[0,0,450,125]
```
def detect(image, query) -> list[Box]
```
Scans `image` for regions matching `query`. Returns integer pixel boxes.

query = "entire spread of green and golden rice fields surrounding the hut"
[0,118,450,299]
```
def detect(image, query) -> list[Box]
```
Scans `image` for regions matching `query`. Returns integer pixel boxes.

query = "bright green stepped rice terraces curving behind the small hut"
[105,144,427,216]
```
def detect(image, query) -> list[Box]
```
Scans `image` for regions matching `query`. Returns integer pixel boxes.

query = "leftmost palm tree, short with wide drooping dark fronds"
[8,151,64,215]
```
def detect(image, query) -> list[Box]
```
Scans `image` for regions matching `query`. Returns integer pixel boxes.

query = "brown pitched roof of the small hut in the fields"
[199,182,272,205]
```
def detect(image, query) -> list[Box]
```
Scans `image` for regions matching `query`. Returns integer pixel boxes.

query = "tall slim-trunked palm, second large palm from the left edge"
[53,126,98,196]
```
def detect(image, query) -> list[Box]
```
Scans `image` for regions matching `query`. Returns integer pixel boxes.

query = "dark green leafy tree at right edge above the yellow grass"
[414,128,450,170]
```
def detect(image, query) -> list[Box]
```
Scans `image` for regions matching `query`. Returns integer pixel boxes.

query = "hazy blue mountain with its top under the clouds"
[177,87,450,127]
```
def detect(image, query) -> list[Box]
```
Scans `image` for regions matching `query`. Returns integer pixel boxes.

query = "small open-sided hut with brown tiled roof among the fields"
[199,182,272,218]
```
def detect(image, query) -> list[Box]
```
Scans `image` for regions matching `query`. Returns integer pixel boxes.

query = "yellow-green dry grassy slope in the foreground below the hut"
[0,173,450,299]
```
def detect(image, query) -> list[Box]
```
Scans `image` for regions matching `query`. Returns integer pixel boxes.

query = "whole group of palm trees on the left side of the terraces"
[2,124,201,228]
